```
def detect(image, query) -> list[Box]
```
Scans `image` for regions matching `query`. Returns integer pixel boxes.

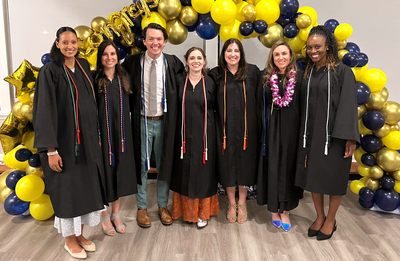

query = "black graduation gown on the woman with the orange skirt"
[170,74,217,198]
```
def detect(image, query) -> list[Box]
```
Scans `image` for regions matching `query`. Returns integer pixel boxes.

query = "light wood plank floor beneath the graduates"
[0,181,400,261]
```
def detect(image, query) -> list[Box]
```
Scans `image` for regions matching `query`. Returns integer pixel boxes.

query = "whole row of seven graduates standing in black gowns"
[33,23,359,258]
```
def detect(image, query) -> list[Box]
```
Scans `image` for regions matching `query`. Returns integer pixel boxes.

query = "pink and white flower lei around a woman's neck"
[269,69,296,107]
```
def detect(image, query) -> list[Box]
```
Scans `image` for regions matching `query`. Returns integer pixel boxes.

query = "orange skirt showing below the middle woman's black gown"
[172,192,219,223]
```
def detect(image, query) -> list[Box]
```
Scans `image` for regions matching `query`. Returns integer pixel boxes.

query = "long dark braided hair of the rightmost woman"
[304,25,340,79]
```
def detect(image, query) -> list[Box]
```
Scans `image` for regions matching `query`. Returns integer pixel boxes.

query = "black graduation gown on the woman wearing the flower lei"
[257,71,303,212]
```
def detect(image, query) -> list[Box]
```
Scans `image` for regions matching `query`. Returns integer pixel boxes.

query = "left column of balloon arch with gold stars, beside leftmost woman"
[0,60,54,220]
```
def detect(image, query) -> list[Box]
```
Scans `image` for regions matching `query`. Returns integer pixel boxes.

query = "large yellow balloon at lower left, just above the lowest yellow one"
[15,175,44,201]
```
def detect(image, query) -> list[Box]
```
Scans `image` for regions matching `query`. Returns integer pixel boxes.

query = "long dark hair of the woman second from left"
[93,39,132,93]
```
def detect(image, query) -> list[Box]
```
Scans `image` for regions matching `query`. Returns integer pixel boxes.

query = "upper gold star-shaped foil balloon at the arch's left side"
[4,60,40,98]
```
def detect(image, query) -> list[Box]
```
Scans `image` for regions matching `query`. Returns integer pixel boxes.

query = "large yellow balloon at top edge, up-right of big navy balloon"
[211,0,237,25]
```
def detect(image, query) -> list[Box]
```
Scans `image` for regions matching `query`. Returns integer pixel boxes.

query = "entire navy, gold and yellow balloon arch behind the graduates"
[0,0,400,220]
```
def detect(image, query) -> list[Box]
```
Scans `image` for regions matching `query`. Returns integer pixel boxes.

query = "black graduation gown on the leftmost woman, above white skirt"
[33,59,107,218]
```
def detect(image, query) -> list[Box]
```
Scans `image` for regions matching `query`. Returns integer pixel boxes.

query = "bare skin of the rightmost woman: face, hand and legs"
[306,35,356,235]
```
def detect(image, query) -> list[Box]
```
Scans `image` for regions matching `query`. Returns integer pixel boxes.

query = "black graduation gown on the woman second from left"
[96,77,137,202]
